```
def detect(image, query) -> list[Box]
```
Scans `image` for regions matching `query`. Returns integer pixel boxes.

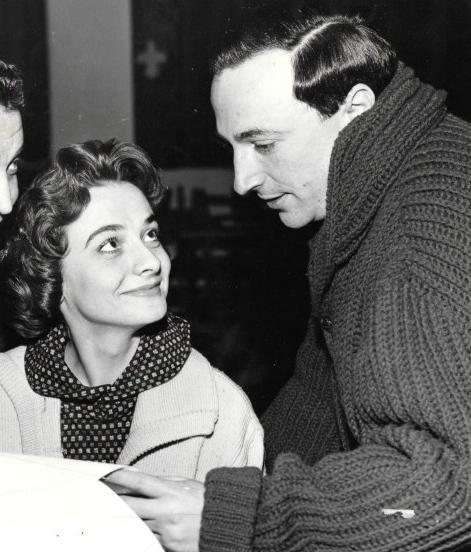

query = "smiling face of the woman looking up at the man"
[61,181,170,330]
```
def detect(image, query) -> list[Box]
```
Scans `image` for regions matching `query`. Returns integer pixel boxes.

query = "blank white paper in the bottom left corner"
[0,454,163,552]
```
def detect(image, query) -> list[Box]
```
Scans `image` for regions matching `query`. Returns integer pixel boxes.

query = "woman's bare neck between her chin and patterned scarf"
[65,326,139,387]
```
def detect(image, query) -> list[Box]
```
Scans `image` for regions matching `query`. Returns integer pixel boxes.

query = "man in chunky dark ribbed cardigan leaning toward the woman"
[107,17,471,552]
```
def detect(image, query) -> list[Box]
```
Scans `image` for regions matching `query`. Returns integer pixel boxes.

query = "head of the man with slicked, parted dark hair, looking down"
[211,16,398,228]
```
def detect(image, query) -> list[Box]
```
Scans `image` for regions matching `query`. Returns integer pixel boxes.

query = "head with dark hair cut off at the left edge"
[0,61,24,221]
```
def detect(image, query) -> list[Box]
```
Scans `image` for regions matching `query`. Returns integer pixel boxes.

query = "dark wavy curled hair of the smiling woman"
[2,139,164,339]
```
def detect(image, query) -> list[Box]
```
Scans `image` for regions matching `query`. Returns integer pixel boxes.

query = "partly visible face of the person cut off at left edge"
[0,106,23,221]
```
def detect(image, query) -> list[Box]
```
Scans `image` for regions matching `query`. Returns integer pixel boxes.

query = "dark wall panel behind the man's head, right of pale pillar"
[132,0,471,166]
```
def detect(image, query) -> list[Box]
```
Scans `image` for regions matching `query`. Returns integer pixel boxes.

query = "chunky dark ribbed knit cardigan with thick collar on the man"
[200,64,471,552]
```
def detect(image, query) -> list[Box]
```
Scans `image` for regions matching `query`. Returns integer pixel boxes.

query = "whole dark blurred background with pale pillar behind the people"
[0,0,471,414]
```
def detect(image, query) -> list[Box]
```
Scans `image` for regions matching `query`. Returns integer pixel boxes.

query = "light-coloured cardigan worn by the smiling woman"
[0,347,263,481]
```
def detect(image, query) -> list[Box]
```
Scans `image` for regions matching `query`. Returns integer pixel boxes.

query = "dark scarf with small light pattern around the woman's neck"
[25,315,191,463]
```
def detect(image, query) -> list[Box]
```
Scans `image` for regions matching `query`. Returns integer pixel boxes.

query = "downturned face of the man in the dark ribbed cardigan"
[211,49,349,228]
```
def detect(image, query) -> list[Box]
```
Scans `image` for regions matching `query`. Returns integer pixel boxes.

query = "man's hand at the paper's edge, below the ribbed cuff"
[103,468,204,552]
